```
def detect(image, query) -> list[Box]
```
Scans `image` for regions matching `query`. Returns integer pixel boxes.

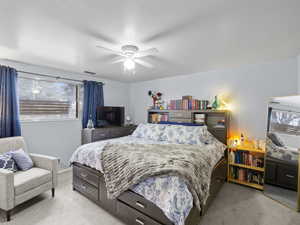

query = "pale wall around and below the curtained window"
[0,60,129,165]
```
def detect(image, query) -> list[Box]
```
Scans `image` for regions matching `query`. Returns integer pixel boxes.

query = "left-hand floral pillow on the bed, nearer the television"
[132,123,167,141]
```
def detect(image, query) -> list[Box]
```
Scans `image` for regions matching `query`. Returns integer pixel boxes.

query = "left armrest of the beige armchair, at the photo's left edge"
[0,169,14,210]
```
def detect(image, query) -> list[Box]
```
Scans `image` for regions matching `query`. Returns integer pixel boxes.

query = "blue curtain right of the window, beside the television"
[82,80,104,128]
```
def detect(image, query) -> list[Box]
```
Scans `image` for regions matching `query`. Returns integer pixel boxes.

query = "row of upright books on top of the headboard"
[168,96,209,110]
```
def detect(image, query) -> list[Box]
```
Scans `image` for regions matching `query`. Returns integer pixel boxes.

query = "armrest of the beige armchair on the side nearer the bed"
[29,153,59,188]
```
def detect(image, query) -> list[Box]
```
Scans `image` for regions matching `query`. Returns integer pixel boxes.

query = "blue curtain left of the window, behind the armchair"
[0,65,21,138]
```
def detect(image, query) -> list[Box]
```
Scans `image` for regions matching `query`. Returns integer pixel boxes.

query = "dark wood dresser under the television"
[81,125,136,144]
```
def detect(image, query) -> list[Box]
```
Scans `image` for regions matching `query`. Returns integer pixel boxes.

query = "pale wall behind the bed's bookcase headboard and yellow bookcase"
[130,58,297,138]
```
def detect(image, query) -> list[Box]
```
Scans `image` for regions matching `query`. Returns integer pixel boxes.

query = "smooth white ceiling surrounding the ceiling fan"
[0,0,300,82]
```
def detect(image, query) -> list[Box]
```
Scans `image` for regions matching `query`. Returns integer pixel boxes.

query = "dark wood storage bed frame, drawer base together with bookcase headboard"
[73,110,230,225]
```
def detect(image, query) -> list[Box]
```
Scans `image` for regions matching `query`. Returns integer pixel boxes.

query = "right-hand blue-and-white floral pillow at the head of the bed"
[162,125,208,145]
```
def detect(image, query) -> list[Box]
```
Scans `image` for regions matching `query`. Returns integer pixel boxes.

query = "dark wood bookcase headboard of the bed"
[148,109,230,144]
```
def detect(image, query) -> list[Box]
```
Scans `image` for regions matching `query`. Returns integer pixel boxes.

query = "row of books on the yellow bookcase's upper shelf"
[229,150,264,168]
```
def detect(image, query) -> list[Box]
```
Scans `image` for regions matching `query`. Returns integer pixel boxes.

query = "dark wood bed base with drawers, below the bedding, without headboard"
[73,158,227,225]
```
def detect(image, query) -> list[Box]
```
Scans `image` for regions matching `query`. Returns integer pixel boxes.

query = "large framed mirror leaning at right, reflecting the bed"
[264,96,300,211]
